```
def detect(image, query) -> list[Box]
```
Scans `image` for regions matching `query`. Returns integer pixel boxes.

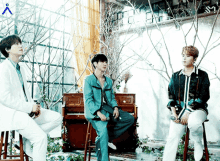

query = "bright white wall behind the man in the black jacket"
[121,16,220,141]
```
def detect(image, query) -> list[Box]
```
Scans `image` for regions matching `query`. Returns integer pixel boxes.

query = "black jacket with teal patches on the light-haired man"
[167,69,210,113]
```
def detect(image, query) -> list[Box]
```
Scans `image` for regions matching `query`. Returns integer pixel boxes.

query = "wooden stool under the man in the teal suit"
[84,121,110,161]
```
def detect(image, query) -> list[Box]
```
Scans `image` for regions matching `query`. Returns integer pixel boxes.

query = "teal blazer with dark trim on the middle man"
[83,74,118,119]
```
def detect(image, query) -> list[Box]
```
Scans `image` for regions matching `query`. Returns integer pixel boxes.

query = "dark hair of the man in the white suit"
[0,35,21,58]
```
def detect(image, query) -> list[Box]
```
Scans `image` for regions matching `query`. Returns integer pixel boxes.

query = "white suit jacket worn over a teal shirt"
[0,59,34,131]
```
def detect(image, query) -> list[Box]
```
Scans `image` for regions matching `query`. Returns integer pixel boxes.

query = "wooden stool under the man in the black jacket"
[183,120,209,161]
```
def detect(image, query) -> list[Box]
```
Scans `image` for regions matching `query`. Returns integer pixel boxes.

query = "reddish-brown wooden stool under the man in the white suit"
[0,131,29,161]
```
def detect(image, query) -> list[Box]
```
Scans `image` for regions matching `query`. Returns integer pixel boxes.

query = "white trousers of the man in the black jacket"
[163,110,207,161]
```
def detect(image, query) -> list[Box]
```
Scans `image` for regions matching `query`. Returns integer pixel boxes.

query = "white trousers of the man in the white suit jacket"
[13,109,62,161]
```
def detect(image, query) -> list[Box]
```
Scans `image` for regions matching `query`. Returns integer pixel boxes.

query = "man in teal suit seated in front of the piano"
[83,54,134,161]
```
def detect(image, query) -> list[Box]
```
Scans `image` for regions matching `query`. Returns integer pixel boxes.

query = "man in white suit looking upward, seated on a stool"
[0,35,62,161]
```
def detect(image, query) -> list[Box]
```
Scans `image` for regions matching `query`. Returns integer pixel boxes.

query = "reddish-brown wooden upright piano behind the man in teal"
[62,93,138,151]
